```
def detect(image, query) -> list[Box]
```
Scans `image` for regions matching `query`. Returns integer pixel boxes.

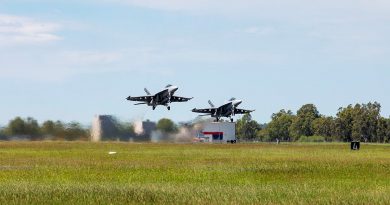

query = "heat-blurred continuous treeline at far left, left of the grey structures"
[0,117,90,141]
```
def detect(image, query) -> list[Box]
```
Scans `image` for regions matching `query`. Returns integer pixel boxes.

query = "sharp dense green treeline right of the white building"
[237,102,390,143]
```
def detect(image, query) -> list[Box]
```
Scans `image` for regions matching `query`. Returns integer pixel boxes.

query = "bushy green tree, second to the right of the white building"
[266,110,295,141]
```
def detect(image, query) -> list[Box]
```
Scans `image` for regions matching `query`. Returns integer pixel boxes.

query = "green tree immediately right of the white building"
[236,114,261,140]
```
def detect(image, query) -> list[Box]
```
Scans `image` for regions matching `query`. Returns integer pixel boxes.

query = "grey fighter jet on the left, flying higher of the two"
[126,85,192,110]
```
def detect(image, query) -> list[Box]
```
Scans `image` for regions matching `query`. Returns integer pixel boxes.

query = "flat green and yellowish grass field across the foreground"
[0,142,390,204]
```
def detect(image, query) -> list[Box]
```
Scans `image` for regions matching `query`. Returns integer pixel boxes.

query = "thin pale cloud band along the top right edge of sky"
[108,0,390,18]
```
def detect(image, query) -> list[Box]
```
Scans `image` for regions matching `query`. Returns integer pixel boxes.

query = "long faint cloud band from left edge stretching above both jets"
[0,42,278,82]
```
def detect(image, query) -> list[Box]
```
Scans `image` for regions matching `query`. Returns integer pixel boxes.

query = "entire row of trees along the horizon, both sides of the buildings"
[0,102,390,143]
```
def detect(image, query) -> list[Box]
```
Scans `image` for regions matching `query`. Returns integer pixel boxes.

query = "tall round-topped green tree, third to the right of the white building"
[290,104,320,138]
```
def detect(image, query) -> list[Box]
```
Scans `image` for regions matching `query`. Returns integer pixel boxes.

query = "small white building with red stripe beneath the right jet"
[200,122,237,143]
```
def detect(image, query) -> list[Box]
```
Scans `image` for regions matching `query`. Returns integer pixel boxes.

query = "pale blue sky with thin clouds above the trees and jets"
[0,0,390,125]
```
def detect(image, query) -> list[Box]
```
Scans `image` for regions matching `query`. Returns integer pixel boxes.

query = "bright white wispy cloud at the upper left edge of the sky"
[0,14,62,45]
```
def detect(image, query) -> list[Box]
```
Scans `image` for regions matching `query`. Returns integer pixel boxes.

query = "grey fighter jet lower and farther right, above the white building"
[192,98,254,122]
